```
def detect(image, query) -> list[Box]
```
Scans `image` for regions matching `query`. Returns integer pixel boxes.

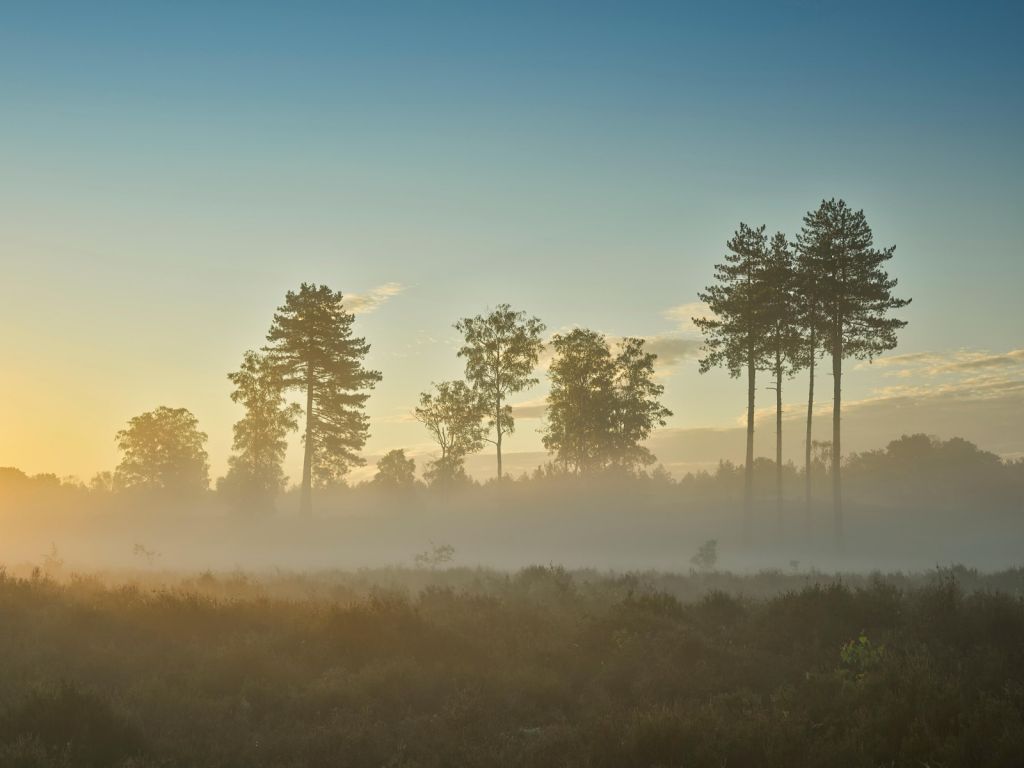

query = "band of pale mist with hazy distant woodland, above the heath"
[0,435,1024,574]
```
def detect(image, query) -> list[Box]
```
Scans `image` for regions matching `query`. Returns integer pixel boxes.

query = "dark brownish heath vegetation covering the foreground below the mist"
[0,567,1024,768]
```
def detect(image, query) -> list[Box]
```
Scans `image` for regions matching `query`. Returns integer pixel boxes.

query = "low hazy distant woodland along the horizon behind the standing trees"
[0,434,1024,514]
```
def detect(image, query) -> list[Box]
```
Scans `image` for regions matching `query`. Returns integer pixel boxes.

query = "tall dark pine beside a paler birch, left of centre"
[264,283,381,515]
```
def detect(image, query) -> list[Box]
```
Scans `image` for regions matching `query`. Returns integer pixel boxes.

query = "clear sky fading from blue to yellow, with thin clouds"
[0,0,1024,478]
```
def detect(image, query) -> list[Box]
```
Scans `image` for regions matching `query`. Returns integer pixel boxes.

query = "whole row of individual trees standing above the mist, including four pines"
[97,200,909,539]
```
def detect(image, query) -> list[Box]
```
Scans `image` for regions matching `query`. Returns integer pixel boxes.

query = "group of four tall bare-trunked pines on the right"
[693,199,910,543]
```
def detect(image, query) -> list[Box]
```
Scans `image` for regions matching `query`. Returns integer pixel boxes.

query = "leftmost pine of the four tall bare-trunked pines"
[693,223,767,535]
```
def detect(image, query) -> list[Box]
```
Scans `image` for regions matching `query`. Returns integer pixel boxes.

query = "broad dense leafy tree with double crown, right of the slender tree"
[543,328,672,475]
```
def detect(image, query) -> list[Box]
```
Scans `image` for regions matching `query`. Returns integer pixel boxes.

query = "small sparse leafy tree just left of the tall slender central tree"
[414,381,487,487]
